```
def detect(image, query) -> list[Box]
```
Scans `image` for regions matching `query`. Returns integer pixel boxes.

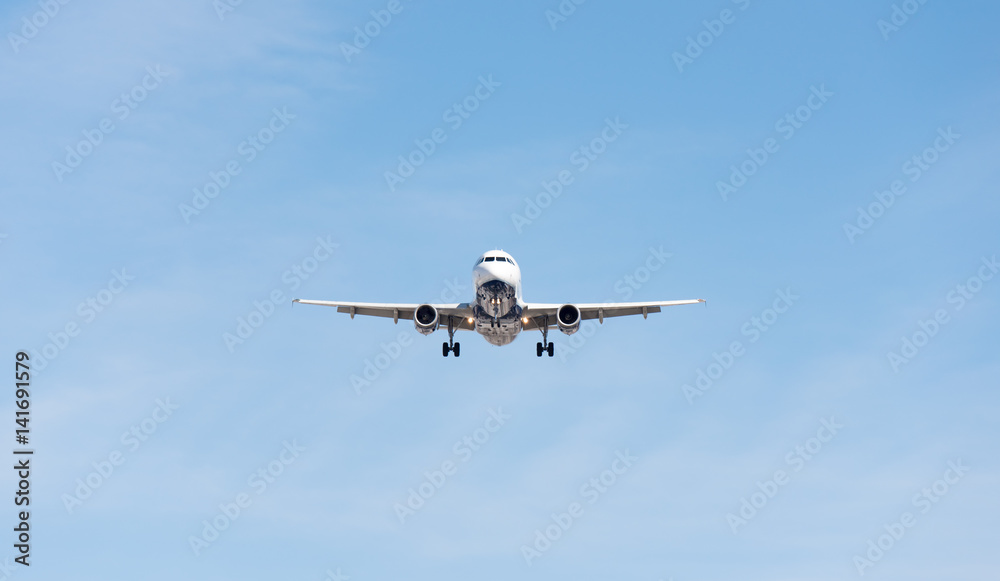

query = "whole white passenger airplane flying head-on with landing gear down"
[292,250,705,357]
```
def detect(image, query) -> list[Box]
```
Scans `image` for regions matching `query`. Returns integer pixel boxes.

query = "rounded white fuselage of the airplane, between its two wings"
[472,250,524,345]
